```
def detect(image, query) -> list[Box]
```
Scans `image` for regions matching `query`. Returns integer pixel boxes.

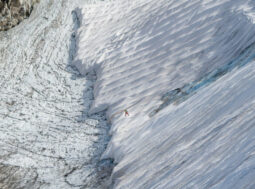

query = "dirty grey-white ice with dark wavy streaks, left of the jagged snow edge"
[0,0,111,189]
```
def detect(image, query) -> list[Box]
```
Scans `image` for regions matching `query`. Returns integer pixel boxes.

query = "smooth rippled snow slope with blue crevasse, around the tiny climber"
[74,0,255,189]
